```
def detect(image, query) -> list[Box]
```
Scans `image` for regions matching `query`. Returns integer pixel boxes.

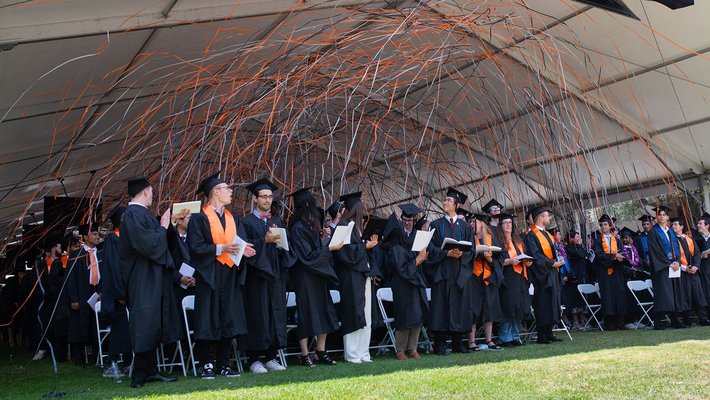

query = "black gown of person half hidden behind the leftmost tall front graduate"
[101,232,131,354]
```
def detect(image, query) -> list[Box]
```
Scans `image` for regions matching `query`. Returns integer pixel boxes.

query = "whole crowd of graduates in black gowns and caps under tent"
[0,174,710,387]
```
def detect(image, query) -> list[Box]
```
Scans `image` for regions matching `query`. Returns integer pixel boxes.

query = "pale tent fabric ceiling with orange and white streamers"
[0,0,710,239]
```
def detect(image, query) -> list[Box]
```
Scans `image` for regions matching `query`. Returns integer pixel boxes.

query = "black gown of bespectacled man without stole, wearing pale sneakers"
[238,213,293,350]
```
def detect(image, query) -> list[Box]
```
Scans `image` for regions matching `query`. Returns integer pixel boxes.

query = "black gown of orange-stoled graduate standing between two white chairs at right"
[594,235,629,316]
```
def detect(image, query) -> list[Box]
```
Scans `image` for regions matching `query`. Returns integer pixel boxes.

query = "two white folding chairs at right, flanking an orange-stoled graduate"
[577,279,653,331]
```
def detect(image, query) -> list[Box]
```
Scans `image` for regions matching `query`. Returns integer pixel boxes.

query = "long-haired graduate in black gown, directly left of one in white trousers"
[288,188,343,367]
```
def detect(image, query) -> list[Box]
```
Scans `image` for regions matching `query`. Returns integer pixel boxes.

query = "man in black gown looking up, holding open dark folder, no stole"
[424,188,475,355]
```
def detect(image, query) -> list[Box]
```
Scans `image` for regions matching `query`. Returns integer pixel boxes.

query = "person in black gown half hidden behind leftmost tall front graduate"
[101,206,132,377]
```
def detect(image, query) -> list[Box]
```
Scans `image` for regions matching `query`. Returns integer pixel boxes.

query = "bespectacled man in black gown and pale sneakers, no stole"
[237,178,293,373]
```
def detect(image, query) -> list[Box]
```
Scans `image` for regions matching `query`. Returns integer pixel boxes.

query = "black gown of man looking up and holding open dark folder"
[422,217,475,333]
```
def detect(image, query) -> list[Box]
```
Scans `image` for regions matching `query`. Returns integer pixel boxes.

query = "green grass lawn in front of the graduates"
[0,327,710,399]
